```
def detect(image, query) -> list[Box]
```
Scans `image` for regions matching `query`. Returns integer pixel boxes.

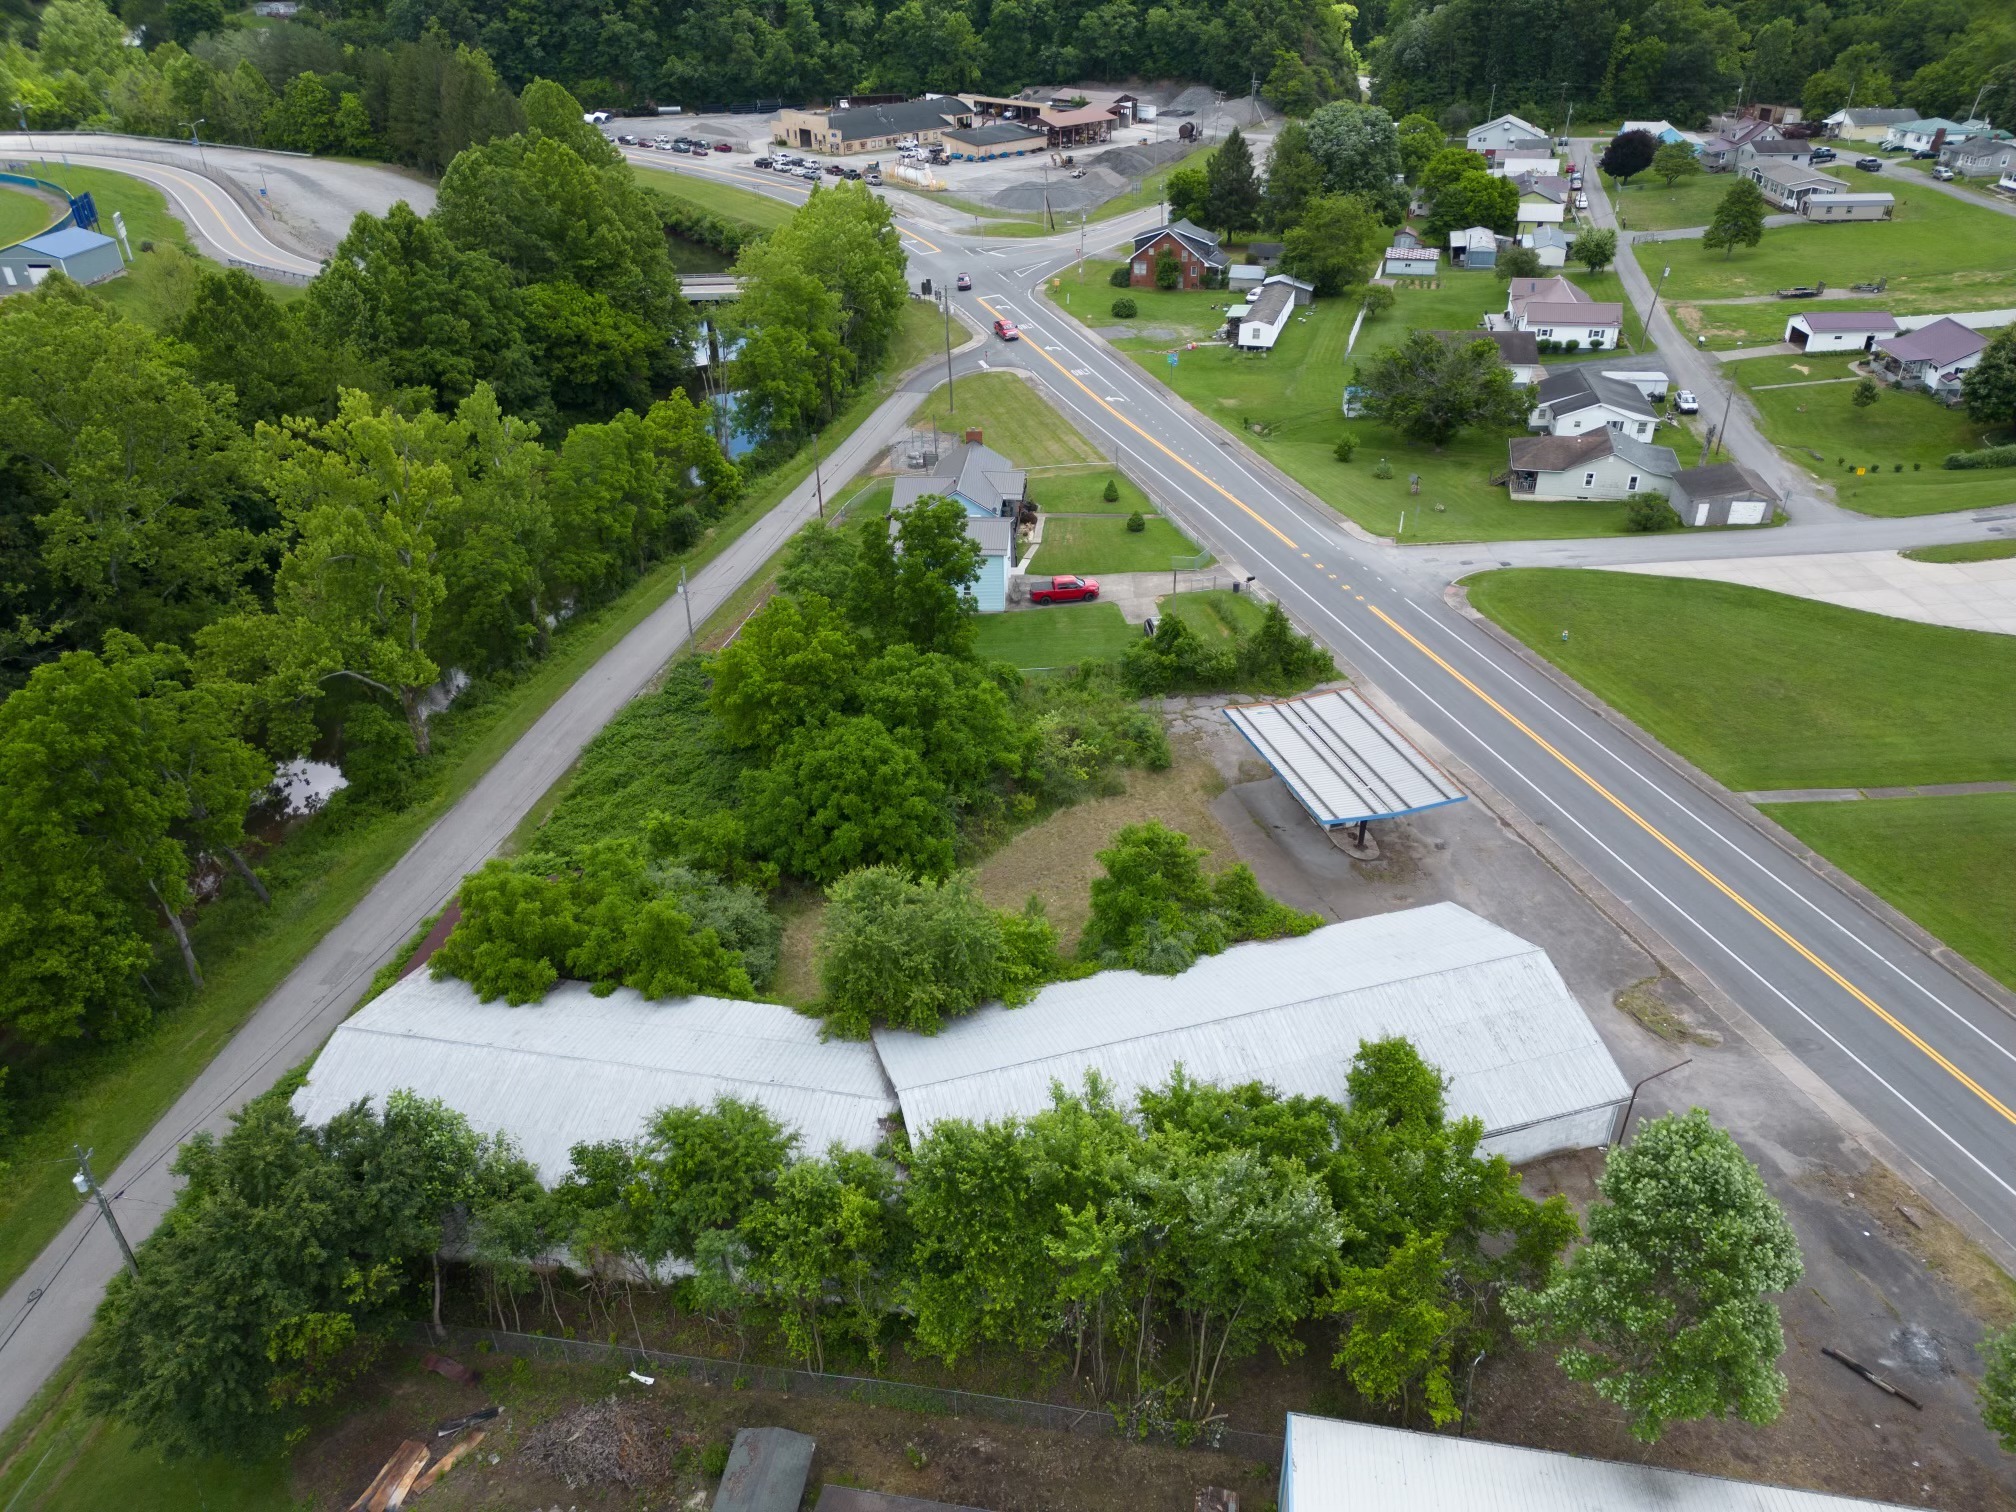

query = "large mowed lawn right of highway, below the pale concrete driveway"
[1470,569,2016,792]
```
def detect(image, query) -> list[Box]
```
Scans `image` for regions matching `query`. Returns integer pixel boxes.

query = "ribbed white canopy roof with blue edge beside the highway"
[1226,687,1464,829]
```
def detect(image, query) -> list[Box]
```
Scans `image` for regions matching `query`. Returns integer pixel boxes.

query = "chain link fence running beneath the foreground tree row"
[427,1329,1282,1466]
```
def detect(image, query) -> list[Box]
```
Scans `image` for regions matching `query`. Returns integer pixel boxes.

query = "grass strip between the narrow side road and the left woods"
[0,334,927,1306]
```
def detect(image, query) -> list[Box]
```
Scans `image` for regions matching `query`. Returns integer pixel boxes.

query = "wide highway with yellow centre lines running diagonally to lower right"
[931,250,2016,1246]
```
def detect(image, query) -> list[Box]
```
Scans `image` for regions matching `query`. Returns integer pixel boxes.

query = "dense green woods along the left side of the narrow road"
[0,85,901,1153]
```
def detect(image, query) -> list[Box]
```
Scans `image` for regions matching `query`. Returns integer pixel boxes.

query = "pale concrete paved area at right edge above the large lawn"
[1613,550,2016,635]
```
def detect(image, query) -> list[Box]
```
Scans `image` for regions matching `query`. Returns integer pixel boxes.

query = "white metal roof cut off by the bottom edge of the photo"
[1280,1413,1927,1512]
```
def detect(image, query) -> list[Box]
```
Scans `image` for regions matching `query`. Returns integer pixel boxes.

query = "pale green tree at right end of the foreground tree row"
[1508,1109,1804,1443]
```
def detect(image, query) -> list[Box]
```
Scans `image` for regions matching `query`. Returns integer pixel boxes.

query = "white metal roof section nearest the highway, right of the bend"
[875,903,1631,1139]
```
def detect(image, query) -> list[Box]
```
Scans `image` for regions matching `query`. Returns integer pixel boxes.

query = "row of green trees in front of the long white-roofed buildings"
[87,1040,1800,1456]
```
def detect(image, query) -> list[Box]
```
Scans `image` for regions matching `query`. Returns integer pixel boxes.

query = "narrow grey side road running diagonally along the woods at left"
[0,348,959,1427]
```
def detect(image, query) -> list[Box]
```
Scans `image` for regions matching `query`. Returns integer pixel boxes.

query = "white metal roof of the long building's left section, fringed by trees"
[294,970,895,1185]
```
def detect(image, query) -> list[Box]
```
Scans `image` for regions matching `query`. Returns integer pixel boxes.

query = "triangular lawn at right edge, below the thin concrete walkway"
[1762,792,2016,986]
